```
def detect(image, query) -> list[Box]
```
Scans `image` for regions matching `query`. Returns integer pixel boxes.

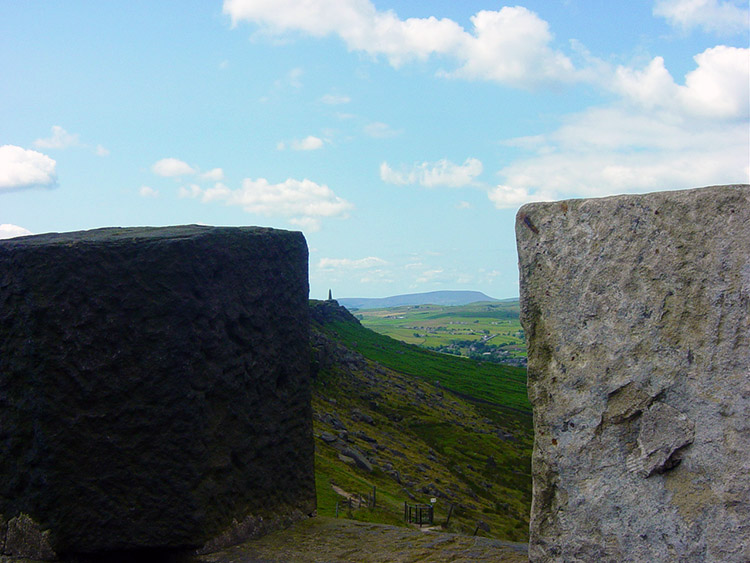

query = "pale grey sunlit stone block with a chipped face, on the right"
[516,185,750,562]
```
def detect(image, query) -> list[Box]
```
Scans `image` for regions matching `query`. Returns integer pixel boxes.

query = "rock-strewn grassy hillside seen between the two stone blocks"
[312,302,532,541]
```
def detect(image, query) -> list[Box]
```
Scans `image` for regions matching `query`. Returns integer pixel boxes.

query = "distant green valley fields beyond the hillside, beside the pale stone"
[352,299,526,363]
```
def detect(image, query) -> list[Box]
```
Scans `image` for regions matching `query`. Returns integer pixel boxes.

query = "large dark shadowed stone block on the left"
[0,226,315,556]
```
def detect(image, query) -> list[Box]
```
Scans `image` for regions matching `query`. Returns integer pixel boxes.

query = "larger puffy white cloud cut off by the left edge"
[0,145,57,191]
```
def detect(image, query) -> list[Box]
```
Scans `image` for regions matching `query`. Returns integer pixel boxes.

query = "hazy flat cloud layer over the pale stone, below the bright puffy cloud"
[488,107,750,207]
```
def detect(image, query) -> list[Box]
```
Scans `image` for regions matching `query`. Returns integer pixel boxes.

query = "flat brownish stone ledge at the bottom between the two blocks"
[197,517,528,563]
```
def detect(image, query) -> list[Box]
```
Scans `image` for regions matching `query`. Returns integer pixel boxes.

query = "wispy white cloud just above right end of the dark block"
[198,178,354,230]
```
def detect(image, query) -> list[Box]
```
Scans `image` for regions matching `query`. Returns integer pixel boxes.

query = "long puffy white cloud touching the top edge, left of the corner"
[224,0,577,87]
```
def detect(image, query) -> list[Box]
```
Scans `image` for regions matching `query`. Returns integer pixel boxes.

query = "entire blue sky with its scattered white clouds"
[0,0,750,298]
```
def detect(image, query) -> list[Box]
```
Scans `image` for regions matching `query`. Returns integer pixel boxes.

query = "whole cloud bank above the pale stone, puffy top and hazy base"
[488,45,750,207]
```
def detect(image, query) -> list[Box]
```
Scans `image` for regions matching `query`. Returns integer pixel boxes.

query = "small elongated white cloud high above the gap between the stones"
[380,158,483,188]
